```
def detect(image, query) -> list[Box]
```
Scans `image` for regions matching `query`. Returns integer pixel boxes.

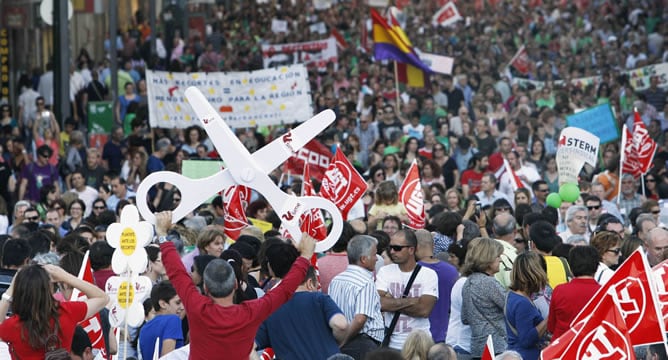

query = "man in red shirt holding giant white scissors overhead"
[155,211,315,360]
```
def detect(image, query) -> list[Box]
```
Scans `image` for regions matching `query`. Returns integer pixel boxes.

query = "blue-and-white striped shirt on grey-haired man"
[328,265,385,341]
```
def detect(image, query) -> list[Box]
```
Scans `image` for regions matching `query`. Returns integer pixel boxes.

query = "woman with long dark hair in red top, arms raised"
[0,265,109,360]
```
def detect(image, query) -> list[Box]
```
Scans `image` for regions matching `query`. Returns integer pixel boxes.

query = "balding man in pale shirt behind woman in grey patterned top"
[492,213,517,289]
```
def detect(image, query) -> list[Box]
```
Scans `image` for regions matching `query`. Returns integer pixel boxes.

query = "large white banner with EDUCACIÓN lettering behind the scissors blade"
[146,64,313,129]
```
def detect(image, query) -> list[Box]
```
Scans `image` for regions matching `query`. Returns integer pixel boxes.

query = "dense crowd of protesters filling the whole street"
[0,0,668,360]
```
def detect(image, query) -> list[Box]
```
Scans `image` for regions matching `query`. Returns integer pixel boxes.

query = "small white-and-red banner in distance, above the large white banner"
[262,37,339,71]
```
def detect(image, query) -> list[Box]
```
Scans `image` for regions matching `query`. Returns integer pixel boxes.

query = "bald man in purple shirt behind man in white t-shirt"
[415,229,459,343]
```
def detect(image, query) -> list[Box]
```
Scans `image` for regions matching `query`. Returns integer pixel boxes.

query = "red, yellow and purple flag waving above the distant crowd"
[371,9,432,87]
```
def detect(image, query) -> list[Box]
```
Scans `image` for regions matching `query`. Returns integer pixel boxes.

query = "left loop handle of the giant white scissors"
[137,169,234,224]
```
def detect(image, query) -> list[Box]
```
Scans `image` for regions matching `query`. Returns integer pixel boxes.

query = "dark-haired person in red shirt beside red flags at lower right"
[547,246,601,339]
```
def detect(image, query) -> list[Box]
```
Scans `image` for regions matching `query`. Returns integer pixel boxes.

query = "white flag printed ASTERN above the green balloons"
[556,127,600,184]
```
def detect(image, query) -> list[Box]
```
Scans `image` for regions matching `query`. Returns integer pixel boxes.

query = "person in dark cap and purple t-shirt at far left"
[19,145,60,202]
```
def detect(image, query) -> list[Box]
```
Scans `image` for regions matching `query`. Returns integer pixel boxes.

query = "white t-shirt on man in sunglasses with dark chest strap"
[376,264,438,350]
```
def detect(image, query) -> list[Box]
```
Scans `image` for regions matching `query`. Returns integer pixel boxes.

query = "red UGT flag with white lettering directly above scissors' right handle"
[320,148,369,220]
